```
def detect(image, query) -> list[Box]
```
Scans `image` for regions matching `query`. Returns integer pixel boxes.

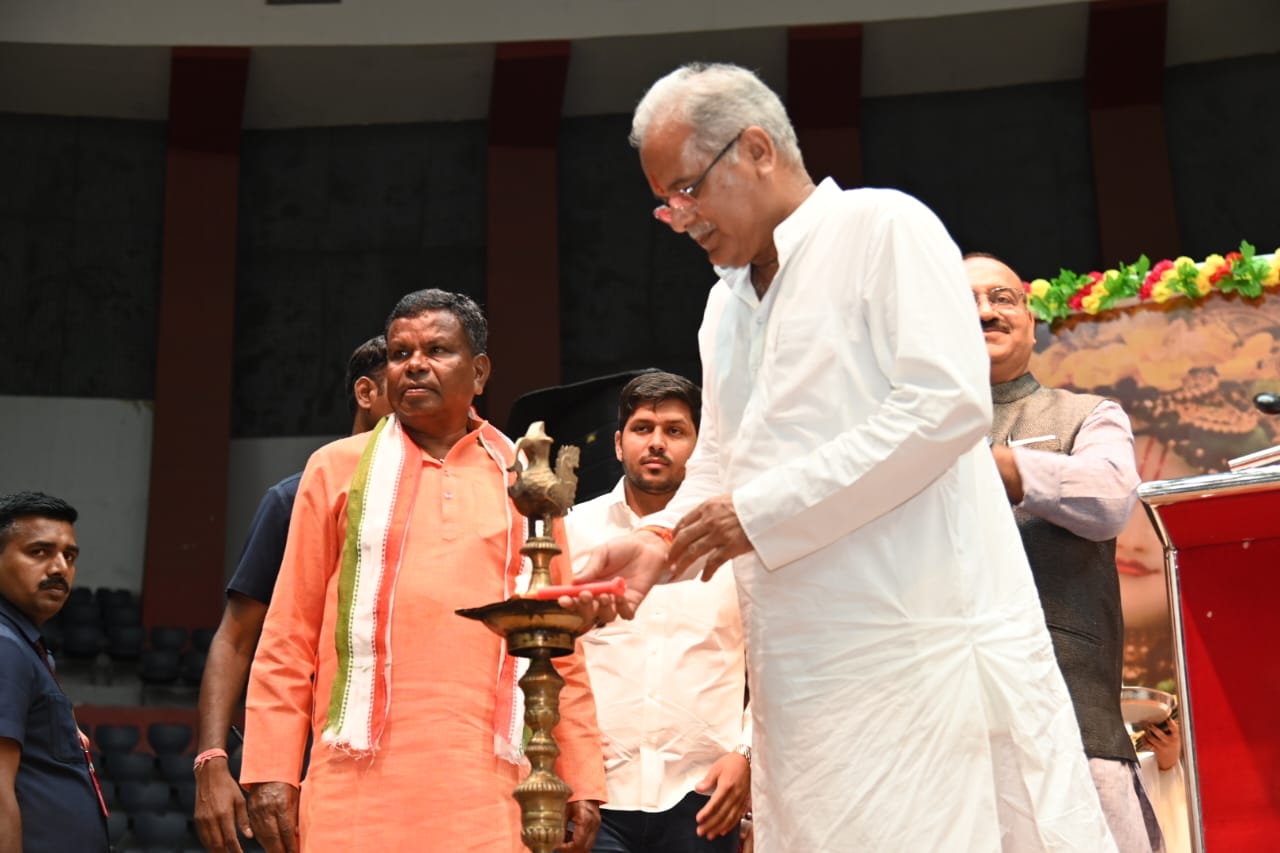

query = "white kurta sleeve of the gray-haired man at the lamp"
[733,193,991,570]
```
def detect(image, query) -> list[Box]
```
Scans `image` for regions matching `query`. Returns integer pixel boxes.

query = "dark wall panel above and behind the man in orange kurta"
[232,123,485,437]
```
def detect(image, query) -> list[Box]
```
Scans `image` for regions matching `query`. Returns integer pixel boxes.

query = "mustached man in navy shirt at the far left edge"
[0,492,109,853]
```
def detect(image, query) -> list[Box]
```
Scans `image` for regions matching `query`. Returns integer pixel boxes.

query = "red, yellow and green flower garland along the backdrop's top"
[1023,241,1280,323]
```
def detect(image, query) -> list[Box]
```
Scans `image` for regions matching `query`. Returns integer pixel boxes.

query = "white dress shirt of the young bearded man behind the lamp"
[564,480,751,812]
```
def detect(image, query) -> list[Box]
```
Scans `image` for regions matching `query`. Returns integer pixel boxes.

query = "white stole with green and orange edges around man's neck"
[321,415,532,765]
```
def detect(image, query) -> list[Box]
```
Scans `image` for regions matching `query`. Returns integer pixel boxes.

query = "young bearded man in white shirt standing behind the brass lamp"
[566,371,751,853]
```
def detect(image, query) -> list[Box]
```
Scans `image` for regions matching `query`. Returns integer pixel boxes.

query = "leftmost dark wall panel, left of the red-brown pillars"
[0,114,165,398]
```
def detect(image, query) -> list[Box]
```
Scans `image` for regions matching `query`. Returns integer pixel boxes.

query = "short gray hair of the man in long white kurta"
[631,63,804,167]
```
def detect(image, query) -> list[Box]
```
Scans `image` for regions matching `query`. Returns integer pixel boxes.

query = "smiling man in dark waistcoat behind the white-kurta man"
[965,255,1164,853]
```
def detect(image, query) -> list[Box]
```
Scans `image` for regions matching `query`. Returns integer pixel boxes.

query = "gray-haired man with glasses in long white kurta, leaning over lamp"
[573,65,1115,853]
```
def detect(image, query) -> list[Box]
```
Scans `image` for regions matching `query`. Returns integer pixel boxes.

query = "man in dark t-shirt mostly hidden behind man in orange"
[196,336,390,850]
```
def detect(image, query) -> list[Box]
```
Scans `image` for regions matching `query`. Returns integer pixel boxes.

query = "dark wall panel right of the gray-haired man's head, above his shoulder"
[863,83,1101,278]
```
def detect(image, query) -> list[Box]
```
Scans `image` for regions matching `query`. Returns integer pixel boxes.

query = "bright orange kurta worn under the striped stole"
[241,424,605,853]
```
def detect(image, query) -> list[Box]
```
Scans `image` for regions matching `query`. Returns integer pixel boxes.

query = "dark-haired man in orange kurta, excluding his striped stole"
[241,291,605,853]
